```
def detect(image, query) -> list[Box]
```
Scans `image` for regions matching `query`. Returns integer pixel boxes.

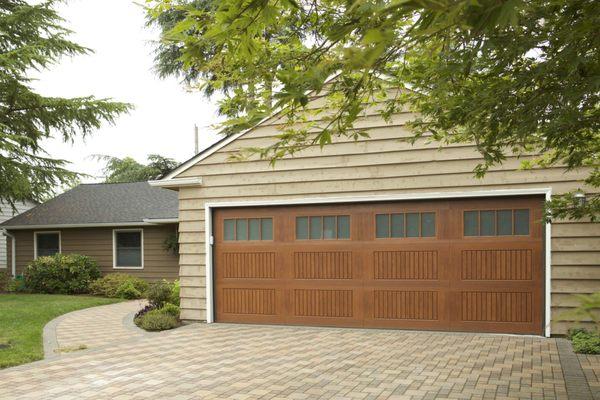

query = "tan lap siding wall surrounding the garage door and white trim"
[172,113,600,334]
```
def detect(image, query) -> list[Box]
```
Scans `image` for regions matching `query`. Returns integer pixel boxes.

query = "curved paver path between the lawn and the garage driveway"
[44,300,146,358]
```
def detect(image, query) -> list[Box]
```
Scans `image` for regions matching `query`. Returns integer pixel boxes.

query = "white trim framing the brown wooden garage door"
[204,188,552,337]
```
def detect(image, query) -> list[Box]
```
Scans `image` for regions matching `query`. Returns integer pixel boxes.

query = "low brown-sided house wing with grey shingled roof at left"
[0,182,179,280]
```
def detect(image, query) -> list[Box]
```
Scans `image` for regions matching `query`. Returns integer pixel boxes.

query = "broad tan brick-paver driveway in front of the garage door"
[0,318,567,400]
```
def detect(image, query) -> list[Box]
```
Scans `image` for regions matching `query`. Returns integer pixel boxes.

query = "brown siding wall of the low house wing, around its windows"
[9,224,179,280]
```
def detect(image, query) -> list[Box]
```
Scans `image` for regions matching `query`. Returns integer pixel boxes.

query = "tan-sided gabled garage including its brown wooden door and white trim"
[150,97,600,335]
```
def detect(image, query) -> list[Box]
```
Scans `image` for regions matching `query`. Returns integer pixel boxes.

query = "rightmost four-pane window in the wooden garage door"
[463,209,529,236]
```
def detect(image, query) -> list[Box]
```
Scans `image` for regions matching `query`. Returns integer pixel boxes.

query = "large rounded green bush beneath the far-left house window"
[23,253,100,294]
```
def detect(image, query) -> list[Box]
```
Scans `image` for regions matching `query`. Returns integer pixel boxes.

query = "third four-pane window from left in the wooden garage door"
[375,212,435,239]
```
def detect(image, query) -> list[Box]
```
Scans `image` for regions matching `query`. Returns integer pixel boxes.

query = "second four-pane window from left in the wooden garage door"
[296,215,350,240]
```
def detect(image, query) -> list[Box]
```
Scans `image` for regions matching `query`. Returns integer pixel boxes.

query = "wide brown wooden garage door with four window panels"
[214,197,544,334]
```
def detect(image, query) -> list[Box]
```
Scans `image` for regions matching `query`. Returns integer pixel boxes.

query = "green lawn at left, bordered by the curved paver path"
[0,294,122,368]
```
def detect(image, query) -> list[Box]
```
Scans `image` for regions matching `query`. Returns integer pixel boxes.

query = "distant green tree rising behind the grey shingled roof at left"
[95,154,178,183]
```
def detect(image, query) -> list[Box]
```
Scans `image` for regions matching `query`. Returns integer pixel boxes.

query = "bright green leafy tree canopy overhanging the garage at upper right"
[148,0,600,218]
